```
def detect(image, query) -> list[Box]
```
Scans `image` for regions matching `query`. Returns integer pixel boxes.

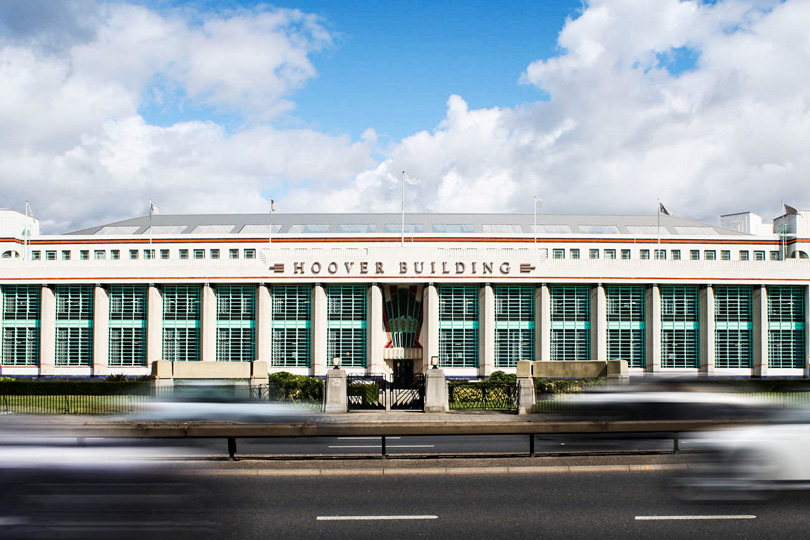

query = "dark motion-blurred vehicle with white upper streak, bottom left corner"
[0,432,219,540]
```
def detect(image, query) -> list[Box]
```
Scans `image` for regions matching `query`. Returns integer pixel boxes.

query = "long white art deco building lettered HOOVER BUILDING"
[0,205,810,377]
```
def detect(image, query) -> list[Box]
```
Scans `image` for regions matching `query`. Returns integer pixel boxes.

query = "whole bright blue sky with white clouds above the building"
[0,0,810,233]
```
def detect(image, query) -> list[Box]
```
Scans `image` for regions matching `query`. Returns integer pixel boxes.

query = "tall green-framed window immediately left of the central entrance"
[326,285,368,367]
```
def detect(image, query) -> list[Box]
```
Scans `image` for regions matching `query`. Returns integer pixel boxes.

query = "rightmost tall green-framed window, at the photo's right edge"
[768,287,807,368]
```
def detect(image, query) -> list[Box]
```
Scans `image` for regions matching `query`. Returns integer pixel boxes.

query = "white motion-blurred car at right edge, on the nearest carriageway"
[674,409,810,502]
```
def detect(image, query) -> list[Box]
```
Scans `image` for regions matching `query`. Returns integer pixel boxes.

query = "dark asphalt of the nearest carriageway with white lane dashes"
[204,472,810,540]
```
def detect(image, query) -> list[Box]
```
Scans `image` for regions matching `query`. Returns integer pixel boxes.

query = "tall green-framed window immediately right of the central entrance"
[438,285,478,367]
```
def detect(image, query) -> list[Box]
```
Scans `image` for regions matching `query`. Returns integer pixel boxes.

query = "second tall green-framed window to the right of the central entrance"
[494,286,534,367]
